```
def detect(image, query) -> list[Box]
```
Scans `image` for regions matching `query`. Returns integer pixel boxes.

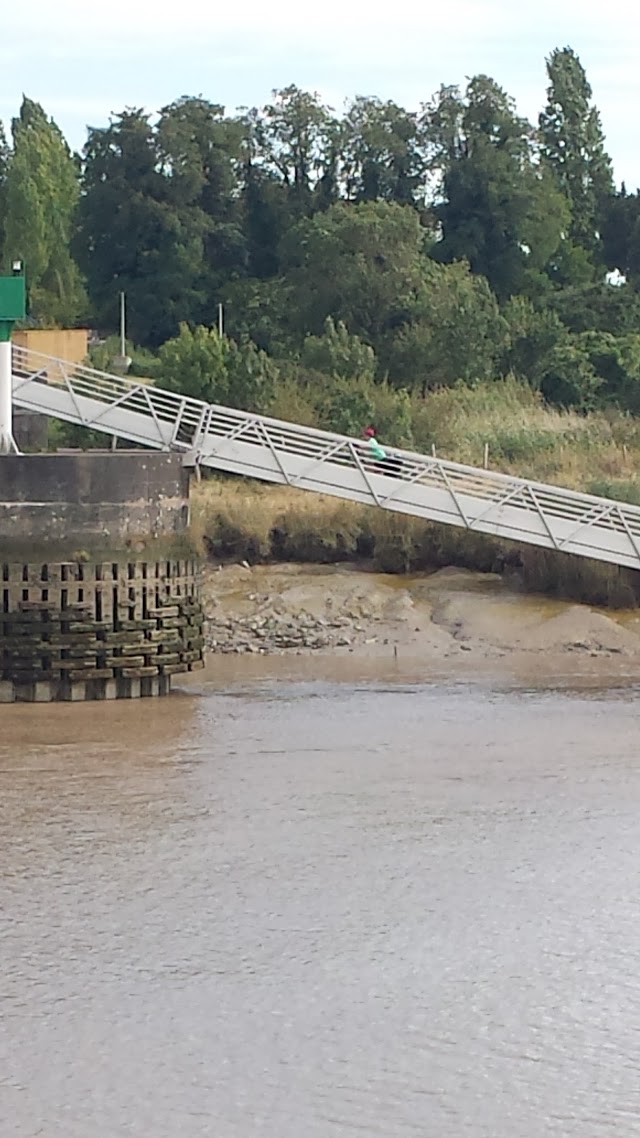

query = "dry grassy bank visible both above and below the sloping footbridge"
[194,379,640,608]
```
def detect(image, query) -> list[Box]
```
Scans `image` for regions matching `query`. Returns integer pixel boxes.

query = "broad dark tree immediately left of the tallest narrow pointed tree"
[425,75,568,300]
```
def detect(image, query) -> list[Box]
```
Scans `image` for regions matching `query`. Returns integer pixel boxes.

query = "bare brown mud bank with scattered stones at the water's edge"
[199,563,640,675]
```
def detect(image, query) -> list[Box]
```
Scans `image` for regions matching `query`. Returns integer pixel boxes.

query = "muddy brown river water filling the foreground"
[0,660,640,1138]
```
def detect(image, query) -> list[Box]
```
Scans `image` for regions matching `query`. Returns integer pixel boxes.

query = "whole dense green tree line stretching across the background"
[0,48,640,436]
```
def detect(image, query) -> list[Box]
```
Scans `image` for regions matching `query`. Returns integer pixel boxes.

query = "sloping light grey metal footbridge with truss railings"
[11,345,640,569]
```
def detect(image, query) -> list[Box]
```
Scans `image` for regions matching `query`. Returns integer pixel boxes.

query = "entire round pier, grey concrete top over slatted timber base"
[0,452,205,703]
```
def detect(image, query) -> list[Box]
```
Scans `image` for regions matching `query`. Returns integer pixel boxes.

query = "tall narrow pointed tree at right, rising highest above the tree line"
[539,48,614,264]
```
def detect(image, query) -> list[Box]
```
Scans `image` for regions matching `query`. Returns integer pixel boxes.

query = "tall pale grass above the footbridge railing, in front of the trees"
[259,376,640,502]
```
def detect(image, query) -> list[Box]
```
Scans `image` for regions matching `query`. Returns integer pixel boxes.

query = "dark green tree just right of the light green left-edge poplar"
[76,109,210,347]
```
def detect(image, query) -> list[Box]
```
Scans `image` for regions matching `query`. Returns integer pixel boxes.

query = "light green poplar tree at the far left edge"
[2,97,85,324]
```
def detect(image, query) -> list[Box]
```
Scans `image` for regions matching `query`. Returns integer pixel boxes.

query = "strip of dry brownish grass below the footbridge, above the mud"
[192,479,640,608]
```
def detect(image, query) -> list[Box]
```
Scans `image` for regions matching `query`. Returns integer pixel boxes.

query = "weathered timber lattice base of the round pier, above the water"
[0,560,204,702]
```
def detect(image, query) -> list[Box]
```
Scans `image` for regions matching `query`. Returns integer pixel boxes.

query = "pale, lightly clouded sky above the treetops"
[0,0,640,190]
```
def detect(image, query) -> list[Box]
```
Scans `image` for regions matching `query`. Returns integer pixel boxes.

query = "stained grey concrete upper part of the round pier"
[0,451,189,560]
